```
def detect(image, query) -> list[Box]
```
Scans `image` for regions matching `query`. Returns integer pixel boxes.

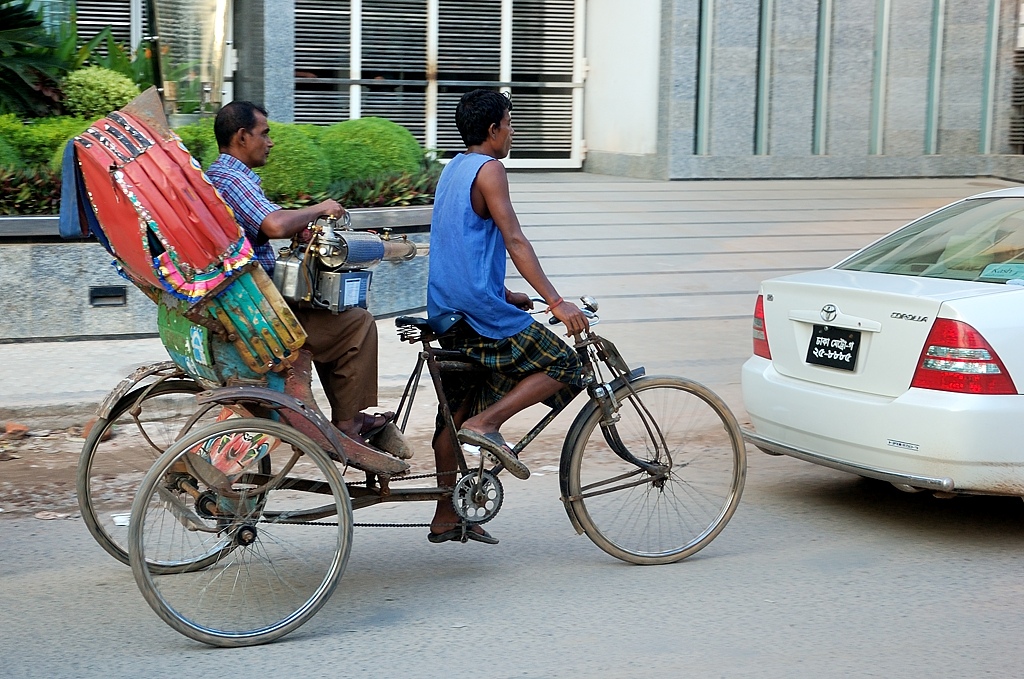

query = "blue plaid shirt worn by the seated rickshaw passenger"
[206,154,281,275]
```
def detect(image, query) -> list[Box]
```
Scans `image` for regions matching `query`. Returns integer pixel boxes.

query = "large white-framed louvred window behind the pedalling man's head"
[295,0,582,167]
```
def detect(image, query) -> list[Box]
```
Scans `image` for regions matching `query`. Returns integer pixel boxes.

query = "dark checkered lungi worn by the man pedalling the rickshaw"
[437,321,584,431]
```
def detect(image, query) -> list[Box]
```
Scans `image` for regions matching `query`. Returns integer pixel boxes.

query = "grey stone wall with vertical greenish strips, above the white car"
[584,0,1024,179]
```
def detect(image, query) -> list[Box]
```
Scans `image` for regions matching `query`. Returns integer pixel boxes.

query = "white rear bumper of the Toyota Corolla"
[741,356,1024,496]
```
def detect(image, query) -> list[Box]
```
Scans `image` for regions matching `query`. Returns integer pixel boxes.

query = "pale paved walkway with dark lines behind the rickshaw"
[0,173,1011,427]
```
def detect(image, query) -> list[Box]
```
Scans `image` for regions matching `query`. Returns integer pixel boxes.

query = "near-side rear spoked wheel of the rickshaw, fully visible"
[128,418,352,646]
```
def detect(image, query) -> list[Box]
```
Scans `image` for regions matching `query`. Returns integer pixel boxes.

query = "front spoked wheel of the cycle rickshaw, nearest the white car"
[562,377,746,564]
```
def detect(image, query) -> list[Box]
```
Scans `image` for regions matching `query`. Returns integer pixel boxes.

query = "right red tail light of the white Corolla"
[910,319,1017,394]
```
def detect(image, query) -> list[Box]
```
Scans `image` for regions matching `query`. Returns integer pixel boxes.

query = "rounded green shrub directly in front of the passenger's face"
[256,122,331,201]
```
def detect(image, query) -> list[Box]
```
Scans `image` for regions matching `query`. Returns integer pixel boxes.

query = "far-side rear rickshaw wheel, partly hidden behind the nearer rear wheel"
[77,379,220,564]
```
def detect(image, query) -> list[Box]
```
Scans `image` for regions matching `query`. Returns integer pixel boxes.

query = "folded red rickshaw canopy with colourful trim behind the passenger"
[61,89,252,304]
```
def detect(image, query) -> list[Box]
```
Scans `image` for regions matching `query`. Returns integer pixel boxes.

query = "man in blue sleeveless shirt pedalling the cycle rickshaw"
[427,89,587,544]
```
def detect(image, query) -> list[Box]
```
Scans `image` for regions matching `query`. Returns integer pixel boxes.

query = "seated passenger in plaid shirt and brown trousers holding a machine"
[206,101,387,441]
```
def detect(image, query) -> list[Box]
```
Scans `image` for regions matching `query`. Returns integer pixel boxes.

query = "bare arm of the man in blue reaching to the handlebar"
[473,162,588,335]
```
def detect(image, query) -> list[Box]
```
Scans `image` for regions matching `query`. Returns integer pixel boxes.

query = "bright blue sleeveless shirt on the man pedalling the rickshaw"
[427,154,532,339]
